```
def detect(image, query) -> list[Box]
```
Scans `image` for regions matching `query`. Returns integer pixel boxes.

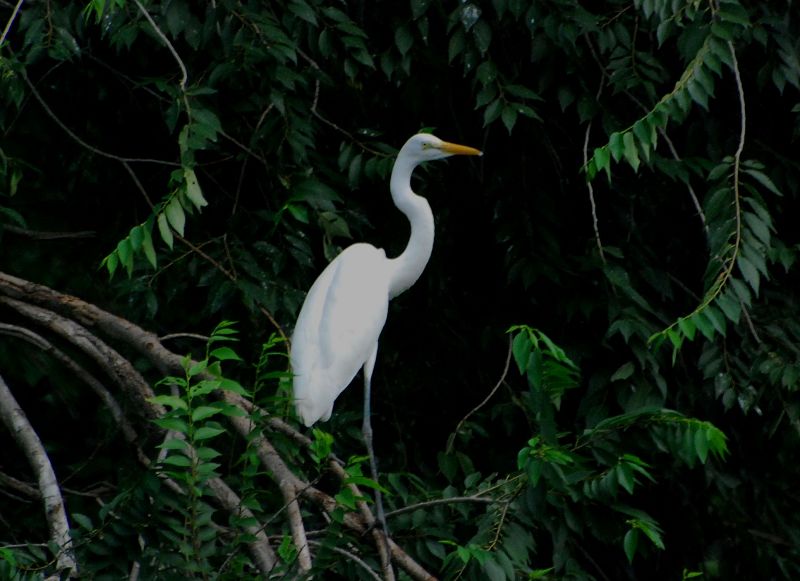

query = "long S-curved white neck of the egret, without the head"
[389,154,434,298]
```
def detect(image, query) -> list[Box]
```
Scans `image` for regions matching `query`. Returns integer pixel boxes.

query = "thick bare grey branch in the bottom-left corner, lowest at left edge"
[0,377,78,577]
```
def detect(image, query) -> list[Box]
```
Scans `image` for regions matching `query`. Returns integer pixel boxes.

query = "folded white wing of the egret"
[291,244,389,425]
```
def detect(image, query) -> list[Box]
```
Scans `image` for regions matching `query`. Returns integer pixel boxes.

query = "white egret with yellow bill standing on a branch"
[290,133,482,526]
